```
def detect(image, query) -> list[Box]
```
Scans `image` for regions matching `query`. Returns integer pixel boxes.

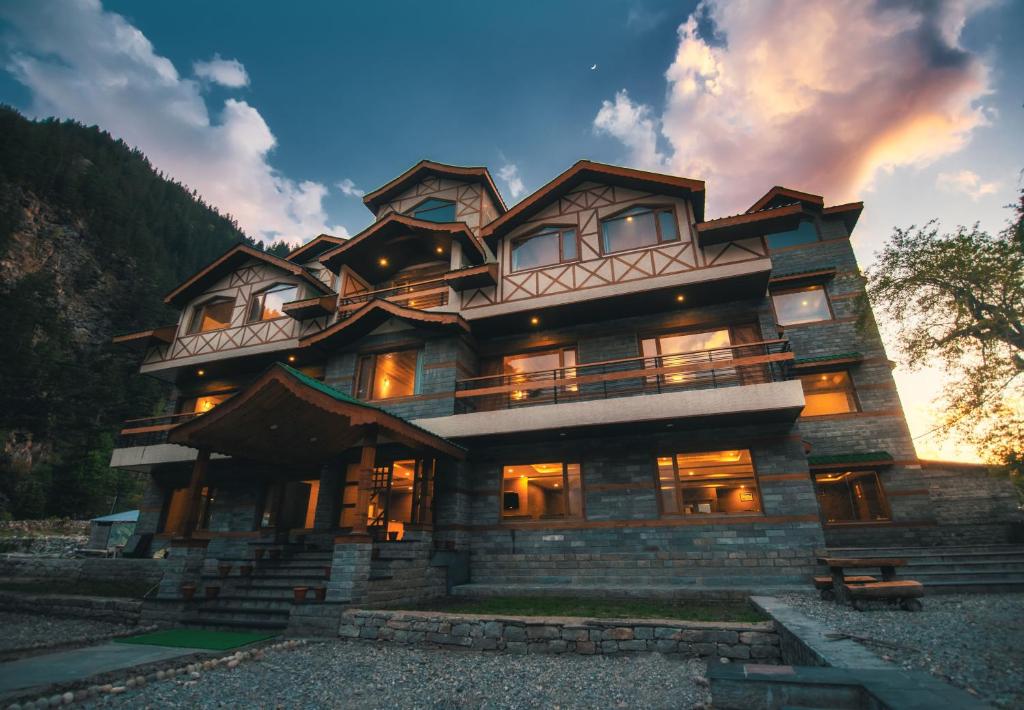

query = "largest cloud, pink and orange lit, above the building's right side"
[594,0,989,212]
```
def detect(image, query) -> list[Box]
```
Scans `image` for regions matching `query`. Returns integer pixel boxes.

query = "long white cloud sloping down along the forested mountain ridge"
[0,0,348,243]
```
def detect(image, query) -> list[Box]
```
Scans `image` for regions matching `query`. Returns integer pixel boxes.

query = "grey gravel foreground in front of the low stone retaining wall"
[81,640,711,710]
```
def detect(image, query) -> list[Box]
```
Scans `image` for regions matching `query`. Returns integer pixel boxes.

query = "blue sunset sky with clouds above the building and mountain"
[0,0,1024,460]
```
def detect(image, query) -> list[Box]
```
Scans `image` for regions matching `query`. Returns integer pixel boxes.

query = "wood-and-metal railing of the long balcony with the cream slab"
[455,340,793,414]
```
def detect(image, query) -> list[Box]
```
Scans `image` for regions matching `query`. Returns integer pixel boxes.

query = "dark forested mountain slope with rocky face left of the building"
[0,107,280,517]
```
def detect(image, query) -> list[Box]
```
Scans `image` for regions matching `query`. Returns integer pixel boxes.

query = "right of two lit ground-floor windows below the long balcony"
[657,449,761,515]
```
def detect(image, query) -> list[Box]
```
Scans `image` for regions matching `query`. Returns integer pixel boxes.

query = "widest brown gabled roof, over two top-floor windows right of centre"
[483,160,705,239]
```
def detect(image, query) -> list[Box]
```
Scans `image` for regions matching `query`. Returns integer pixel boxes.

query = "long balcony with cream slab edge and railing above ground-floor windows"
[416,340,804,438]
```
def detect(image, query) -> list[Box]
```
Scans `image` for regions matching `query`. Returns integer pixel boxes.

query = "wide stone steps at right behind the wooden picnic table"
[827,545,1024,594]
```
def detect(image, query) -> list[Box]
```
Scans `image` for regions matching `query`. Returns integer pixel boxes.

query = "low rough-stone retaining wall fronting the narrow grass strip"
[338,610,780,663]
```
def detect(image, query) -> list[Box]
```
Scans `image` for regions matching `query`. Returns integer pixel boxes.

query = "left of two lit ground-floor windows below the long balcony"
[502,462,583,520]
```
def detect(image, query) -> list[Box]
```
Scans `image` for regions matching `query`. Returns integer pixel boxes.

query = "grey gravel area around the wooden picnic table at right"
[780,594,1024,708]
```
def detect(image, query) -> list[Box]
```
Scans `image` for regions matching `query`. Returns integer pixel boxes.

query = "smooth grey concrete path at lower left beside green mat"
[0,643,209,698]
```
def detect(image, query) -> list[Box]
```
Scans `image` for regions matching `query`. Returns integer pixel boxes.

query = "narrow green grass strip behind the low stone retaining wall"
[387,596,767,622]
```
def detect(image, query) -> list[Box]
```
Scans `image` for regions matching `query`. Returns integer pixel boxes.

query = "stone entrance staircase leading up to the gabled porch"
[182,545,332,630]
